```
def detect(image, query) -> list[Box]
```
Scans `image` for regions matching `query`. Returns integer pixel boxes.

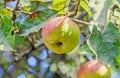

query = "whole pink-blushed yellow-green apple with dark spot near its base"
[42,16,80,54]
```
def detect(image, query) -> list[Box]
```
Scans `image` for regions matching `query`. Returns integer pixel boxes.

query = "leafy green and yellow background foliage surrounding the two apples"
[0,0,120,78]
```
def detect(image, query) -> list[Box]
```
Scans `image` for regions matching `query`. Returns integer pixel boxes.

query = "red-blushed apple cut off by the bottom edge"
[77,60,111,78]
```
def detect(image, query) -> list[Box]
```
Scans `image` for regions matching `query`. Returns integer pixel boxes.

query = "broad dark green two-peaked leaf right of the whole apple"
[88,22,120,66]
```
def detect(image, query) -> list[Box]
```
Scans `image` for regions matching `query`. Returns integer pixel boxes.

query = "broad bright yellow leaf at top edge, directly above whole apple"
[53,0,68,14]
